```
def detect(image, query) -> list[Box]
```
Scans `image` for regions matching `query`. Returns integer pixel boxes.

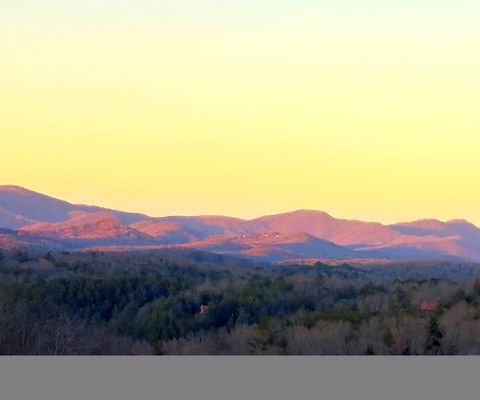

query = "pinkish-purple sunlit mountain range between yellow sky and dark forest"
[0,186,480,261]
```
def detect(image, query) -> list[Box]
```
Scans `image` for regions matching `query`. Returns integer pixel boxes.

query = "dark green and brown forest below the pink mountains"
[0,250,480,355]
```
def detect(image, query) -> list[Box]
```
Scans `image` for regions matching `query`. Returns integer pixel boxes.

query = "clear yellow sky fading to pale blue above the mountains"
[0,0,480,225]
